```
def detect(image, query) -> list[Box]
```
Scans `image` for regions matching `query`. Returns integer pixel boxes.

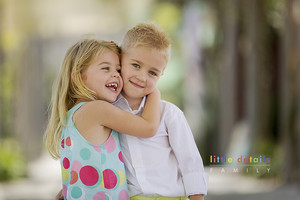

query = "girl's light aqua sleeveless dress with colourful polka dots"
[60,102,129,200]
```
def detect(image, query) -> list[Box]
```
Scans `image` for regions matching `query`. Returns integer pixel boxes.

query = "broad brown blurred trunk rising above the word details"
[243,0,274,150]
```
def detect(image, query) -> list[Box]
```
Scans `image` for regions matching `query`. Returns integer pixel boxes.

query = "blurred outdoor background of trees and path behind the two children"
[0,0,300,200]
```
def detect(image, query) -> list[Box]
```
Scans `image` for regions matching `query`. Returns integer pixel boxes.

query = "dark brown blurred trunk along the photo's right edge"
[280,0,300,182]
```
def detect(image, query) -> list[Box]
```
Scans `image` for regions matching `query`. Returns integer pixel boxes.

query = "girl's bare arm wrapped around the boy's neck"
[87,89,160,137]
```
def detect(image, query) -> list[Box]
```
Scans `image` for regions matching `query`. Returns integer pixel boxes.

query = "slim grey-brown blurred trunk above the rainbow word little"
[218,0,239,153]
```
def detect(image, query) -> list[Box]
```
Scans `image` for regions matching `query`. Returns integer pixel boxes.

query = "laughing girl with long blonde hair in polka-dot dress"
[45,39,160,200]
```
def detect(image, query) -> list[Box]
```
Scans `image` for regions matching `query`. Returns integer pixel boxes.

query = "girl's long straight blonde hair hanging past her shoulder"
[44,39,120,159]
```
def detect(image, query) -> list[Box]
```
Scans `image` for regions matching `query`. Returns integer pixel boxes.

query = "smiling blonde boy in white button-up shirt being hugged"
[56,23,208,200]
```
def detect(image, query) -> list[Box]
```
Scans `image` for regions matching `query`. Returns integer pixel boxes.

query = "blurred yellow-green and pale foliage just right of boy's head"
[152,2,184,108]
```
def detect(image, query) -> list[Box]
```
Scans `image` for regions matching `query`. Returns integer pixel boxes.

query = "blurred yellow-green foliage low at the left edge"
[0,138,26,181]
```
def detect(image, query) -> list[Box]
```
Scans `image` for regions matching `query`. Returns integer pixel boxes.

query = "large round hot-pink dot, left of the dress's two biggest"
[79,166,99,186]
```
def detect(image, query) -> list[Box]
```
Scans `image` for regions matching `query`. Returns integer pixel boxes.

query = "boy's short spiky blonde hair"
[121,22,171,60]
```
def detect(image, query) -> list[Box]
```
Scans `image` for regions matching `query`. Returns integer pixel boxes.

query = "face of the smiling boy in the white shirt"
[121,47,167,100]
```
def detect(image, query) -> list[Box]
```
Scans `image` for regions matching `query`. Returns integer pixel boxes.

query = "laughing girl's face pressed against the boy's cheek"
[81,51,123,102]
